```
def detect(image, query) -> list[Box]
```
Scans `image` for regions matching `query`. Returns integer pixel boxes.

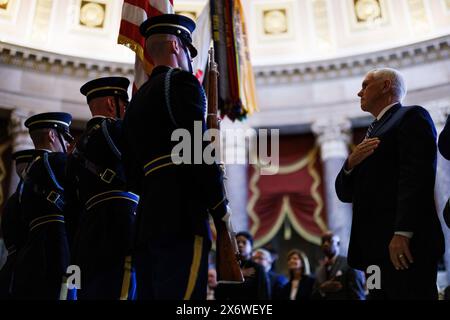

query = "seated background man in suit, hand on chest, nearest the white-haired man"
[313,232,366,300]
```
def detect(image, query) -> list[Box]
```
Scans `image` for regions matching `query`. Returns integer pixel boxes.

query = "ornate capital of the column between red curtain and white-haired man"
[311,118,351,160]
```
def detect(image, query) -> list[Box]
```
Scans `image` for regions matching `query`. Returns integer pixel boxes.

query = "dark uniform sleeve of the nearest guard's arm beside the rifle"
[171,71,228,218]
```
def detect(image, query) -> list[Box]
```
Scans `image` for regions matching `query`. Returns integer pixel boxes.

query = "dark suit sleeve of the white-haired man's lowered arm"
[394,107,437,232]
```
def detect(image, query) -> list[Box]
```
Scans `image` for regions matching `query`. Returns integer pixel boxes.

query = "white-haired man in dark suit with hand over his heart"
[336,68,444,299]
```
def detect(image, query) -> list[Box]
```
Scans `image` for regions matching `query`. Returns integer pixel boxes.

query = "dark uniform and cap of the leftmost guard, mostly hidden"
[0,149,44,299]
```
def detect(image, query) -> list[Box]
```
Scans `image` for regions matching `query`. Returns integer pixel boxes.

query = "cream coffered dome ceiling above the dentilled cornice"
[0,0,450,66]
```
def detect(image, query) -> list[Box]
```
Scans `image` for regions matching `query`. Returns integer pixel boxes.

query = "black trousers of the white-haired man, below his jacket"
[366,258,438,300]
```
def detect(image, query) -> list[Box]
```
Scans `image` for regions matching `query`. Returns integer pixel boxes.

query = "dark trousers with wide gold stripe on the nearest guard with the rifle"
[134,236,211,300]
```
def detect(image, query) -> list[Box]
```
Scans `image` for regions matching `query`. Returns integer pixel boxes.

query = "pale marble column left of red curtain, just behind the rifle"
[221,119,250,232]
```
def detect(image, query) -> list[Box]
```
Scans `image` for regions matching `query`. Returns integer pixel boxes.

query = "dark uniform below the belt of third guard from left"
[73,200,136,300]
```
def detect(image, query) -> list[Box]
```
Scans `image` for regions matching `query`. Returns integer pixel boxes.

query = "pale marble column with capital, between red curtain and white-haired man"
[312,118,352,256]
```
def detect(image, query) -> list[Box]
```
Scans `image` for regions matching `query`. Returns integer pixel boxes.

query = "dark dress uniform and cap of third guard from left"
[66,77,139,300]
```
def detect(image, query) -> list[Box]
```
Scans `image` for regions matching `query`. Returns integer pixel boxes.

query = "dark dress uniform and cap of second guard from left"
[12,112,72,300]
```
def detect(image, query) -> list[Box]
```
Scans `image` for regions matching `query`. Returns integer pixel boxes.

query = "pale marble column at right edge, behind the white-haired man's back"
[429,100,450,286]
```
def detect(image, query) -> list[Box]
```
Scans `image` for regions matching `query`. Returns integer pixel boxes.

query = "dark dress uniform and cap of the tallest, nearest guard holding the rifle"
[123,15,227,299]
